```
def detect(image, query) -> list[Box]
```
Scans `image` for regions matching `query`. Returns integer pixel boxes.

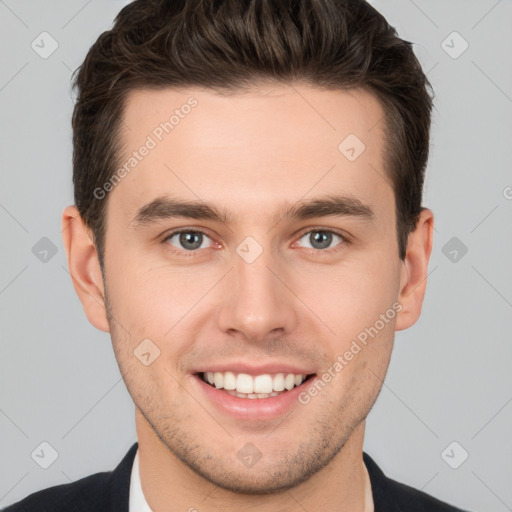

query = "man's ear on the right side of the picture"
[395,208,434,331]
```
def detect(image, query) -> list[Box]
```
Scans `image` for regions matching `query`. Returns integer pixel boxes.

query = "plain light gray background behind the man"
[0,0,512,512]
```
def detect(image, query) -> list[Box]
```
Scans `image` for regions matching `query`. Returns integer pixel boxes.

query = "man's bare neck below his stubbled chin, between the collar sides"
[135,408,371,512]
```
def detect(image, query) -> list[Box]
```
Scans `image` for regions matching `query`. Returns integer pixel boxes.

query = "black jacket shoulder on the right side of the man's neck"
[363,453,468,512]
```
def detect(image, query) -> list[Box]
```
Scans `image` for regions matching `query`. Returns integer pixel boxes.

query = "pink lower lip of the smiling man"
[193,374,315,421]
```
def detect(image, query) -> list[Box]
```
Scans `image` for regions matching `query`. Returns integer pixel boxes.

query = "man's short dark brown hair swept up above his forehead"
[72,0,432,264]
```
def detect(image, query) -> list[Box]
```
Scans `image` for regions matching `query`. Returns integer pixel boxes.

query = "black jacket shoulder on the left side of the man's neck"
[2,443,138,512]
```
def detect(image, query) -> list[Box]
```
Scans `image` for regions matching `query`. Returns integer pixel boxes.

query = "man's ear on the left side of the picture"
[62,205,110,332]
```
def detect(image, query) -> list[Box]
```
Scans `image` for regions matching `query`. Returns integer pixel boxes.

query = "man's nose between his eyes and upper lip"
[217,244,300,342]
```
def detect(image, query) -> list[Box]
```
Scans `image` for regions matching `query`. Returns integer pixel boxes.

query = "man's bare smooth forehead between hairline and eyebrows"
[109,85,393,226]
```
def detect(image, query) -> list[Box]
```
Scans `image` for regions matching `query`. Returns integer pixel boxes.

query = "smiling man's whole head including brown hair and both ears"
[63,0,433,492]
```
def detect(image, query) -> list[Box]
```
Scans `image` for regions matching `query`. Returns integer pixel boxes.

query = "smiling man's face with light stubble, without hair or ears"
[100,86,402,492]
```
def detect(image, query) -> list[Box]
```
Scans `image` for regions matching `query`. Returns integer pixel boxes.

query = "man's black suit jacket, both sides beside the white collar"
[4,443,472,512]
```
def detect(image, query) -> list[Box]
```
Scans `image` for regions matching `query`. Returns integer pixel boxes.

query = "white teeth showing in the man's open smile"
[203,371,306,398]
